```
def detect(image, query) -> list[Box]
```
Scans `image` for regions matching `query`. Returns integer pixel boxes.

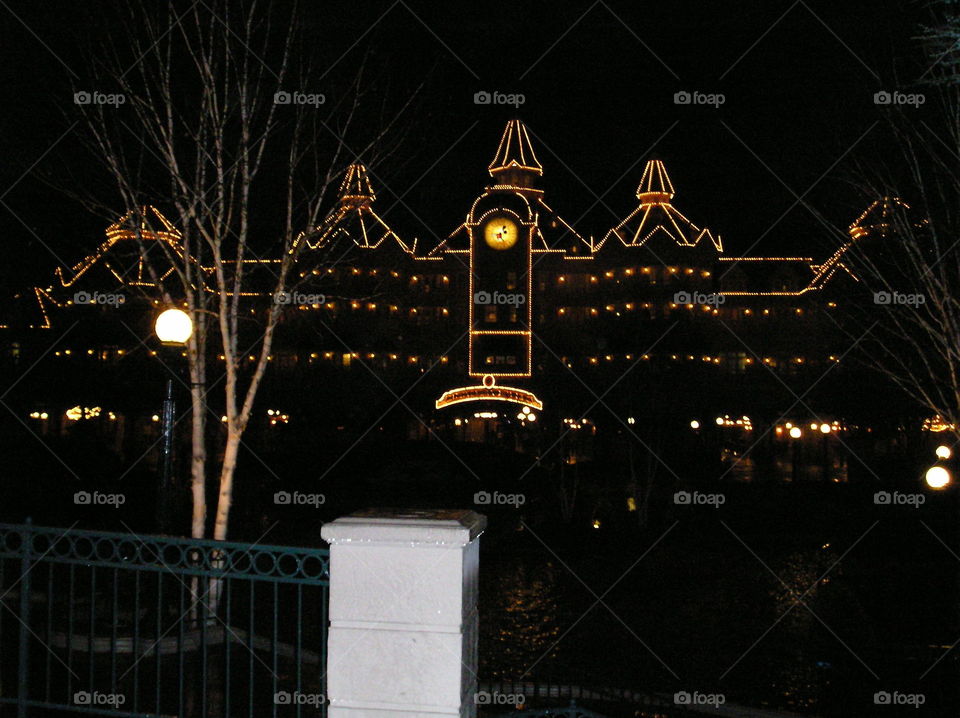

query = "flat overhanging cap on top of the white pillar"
[320,509,487,548]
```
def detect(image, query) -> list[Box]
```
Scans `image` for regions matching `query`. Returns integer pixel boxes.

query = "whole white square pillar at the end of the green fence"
[321,510,487,718]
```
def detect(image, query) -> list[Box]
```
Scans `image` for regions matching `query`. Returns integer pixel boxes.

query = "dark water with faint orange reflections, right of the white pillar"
[480,492,960,716]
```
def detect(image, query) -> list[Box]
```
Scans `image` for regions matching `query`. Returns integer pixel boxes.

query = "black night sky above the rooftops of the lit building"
[0,0,932,291]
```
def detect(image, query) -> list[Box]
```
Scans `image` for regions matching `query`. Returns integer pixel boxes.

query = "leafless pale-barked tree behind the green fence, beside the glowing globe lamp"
[82,0,409,540]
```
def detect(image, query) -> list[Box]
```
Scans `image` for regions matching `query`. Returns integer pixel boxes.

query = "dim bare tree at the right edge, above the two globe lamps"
[848,86,960,438]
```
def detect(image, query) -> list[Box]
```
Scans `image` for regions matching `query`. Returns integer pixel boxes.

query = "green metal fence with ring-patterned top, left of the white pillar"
[0,523,329,718]
